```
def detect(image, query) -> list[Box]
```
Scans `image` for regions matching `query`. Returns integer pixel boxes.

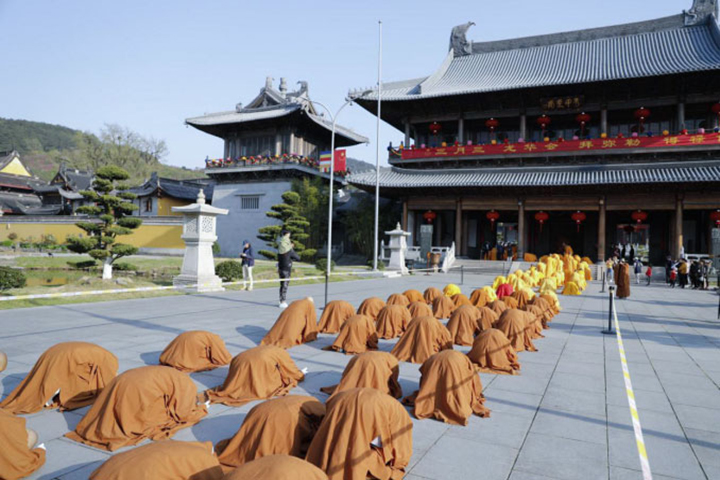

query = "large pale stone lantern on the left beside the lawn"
[172,190,228,292]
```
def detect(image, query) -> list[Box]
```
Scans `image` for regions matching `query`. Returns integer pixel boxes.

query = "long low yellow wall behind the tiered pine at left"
[0,220,185,249]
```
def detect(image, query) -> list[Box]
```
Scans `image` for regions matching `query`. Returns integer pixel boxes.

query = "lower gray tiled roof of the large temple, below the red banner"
[348,160,720,188]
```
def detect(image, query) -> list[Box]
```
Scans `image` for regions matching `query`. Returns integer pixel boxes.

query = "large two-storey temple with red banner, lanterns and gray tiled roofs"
[349,0,720,265]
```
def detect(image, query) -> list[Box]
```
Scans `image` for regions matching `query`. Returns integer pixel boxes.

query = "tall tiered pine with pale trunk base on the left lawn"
[67,165,142,280]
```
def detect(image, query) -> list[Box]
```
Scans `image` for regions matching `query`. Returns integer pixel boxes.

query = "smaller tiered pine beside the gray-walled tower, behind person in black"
[258,191,316,261]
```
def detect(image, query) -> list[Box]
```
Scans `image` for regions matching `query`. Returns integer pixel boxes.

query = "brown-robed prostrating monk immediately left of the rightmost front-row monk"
[216,395,325,470]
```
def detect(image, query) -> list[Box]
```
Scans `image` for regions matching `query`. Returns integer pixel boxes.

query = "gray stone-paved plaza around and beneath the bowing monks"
[0,274,720,480]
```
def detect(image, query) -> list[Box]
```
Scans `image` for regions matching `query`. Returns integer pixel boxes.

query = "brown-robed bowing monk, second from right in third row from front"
[390,317,452,363]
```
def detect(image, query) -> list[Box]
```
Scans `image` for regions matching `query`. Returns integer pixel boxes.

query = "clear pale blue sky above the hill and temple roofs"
[0,0,692,167]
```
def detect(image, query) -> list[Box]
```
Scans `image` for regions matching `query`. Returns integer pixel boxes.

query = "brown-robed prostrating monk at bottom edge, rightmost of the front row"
[306,388,412,480]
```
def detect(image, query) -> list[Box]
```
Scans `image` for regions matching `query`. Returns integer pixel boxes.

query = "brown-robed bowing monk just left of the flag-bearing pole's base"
[260,297,318,348]
